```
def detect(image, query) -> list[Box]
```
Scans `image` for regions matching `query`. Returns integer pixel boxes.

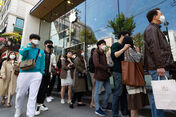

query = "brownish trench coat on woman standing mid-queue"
[73,57,86,93]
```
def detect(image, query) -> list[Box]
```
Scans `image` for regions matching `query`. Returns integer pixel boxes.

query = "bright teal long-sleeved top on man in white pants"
[19,43,45,74]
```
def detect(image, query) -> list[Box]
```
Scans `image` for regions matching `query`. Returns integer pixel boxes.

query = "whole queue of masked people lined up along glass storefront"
[0,8,173,117]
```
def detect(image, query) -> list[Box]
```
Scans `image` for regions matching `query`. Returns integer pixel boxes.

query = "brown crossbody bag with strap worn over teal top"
[19,49,40,71]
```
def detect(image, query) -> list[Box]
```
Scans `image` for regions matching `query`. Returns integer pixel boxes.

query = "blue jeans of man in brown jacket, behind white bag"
[148,70,169,117]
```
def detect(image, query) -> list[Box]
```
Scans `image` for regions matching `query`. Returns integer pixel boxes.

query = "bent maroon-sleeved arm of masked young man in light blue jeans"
[93,52,108,71]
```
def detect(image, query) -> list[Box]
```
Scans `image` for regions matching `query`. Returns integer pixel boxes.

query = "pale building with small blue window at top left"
[0,0,39,34]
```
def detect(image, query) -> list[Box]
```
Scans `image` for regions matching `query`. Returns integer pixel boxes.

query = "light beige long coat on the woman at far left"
[0,61,17,96]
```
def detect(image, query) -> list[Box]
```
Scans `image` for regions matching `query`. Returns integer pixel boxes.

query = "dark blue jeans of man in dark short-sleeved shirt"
[112,72,123,116]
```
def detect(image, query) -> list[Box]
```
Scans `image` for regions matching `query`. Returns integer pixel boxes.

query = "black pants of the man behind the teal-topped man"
[37,74,50,104]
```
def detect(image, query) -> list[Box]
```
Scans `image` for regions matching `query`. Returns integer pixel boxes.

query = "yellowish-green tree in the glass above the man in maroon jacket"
[80,29,97,45]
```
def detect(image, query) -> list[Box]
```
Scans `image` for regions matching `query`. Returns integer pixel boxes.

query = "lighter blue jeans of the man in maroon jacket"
[94,79,111,110]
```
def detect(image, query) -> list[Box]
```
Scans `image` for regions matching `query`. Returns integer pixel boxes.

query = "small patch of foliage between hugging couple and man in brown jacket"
[133,33,144,53]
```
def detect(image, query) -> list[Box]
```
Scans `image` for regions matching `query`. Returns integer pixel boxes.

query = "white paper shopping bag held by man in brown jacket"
[151,78,176,110]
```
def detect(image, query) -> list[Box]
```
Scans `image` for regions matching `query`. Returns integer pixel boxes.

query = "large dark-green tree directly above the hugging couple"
[108,13,136,39]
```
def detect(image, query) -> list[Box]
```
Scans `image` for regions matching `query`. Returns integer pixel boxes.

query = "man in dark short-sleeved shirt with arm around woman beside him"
[111,31,130,117]
